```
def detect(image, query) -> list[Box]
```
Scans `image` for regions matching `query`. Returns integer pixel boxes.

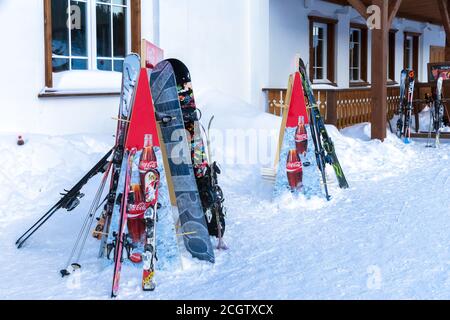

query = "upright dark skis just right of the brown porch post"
[397,70,415,144]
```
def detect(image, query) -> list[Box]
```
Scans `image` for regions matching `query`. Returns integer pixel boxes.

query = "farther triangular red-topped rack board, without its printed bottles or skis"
[273,72,324,199]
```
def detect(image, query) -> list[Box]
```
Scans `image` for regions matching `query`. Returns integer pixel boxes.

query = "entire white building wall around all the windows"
[0,0,445,134]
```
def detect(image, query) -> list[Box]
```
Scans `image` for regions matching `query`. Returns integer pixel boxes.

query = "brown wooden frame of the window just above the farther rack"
[308,15,338,87]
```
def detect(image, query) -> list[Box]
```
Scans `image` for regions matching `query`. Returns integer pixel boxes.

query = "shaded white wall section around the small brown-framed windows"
[267,0,445,88]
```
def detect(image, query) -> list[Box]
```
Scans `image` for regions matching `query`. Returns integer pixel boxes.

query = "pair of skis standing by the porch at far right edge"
[426,74,444,148]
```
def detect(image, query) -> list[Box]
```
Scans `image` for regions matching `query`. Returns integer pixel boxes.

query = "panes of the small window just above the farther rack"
[312,23,327,80]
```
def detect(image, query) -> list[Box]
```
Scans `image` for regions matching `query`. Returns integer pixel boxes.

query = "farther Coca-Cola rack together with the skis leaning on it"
[272,59,349,200]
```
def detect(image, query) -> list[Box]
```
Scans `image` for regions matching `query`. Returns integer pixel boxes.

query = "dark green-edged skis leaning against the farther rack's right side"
[299,59,349,191]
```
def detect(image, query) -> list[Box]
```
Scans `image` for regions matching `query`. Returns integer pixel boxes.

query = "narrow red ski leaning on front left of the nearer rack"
[111,149,136,298]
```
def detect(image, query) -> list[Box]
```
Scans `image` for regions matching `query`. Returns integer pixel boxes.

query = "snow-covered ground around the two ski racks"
[0,92,450,299]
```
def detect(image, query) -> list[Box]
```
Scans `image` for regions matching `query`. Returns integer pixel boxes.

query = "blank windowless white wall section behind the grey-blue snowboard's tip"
[160,0,251,101]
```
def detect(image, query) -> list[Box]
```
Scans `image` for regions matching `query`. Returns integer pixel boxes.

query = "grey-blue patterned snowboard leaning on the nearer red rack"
[150,60,215,263]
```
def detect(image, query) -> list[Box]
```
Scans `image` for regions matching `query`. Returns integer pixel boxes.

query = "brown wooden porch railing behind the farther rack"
[263,83,432,130]
